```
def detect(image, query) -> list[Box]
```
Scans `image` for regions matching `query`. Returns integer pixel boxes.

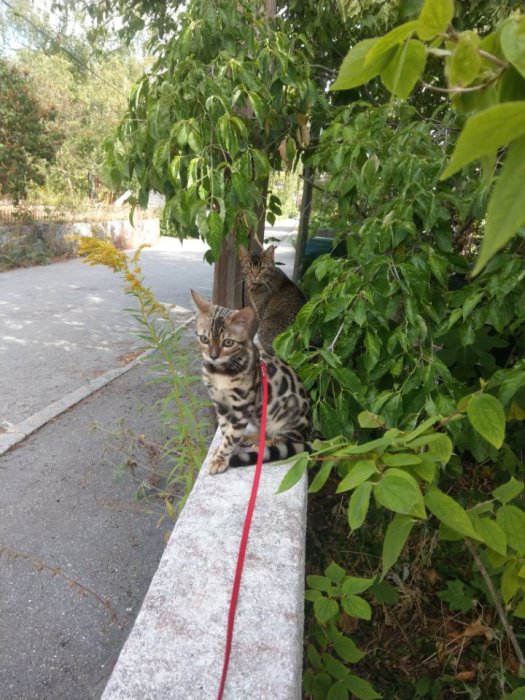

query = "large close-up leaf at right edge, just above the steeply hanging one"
[440,101,525,180]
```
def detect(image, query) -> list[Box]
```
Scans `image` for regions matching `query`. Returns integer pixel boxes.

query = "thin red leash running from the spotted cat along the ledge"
[217,360,268,700]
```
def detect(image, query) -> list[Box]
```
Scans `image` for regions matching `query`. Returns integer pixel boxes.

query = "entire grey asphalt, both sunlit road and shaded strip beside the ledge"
[0,223,293,700]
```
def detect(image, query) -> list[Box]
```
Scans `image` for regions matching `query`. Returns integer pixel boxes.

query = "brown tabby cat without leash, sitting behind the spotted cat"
[239,245,306,354]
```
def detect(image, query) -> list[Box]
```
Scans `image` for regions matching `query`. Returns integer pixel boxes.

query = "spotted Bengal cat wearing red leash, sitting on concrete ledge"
[190,290,311,474]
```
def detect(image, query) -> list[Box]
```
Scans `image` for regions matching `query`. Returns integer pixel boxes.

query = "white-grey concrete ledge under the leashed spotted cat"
[102,434,307,700]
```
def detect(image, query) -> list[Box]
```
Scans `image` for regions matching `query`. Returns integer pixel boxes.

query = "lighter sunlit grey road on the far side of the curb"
[0,228,293,432]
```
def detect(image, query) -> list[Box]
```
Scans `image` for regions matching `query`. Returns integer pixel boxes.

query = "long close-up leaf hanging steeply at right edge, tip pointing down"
[472,135,525,275]
